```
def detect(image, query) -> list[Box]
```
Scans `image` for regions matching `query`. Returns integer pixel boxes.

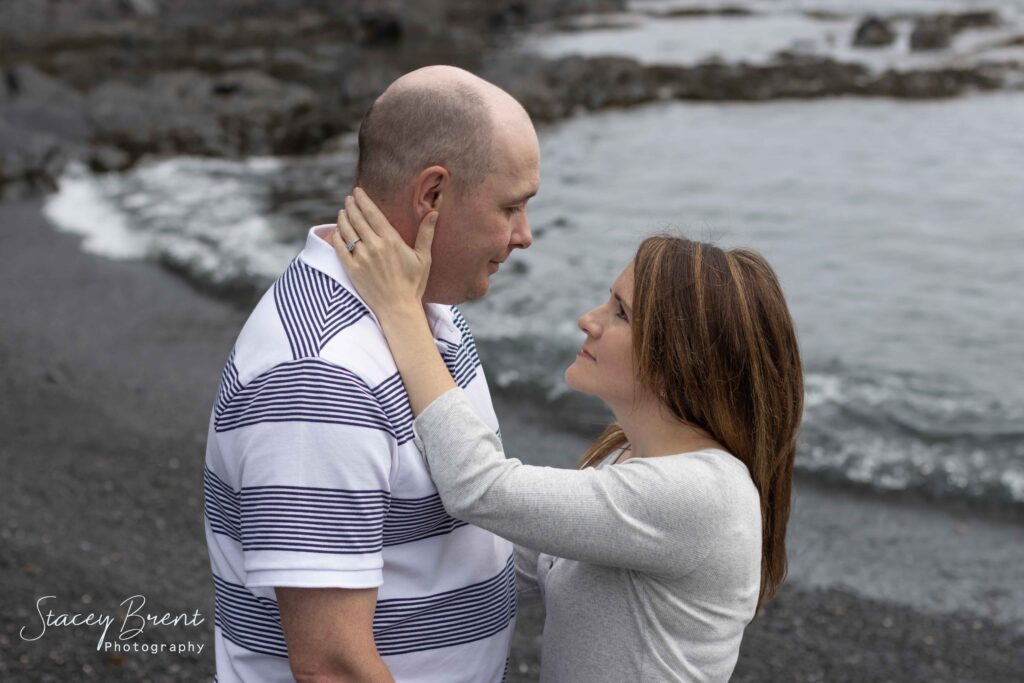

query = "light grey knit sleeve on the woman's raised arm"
[414,389,741,577]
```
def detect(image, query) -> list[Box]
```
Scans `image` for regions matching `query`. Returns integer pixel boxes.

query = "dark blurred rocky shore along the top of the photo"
[0,0,1024,197]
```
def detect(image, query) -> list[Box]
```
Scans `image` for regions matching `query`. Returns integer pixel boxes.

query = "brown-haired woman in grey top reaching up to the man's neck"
[335,190,803,683]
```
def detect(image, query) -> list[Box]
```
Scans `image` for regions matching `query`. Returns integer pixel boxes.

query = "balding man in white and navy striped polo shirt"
[205,67,540,683]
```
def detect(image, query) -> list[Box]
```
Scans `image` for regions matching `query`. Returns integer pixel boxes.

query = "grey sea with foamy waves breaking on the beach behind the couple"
[46,3,1024,508]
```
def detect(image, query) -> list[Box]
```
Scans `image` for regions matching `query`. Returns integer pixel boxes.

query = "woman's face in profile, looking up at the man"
[565,261,636,411]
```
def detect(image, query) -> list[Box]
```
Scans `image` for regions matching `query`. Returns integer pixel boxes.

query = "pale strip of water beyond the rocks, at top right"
[520,0,1024,69]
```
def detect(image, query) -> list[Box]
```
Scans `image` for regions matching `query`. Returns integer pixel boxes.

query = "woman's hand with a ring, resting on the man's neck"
[333,187,437,318]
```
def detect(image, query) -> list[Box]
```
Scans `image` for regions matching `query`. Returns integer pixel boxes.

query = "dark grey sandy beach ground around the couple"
[0,201,1024,681]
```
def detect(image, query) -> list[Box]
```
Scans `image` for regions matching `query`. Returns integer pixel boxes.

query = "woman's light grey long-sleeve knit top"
[414,389,761,683]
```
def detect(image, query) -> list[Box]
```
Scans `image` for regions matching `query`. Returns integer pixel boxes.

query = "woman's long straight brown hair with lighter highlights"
[580,234,804,610]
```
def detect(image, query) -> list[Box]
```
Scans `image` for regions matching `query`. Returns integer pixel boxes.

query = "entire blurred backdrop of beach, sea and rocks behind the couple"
[0,0,1024,681]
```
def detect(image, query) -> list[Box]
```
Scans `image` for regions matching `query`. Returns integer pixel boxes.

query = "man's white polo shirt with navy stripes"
[204,225,516,683]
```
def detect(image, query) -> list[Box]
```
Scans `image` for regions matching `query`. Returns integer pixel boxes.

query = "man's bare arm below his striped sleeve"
[274,587,394,683]
